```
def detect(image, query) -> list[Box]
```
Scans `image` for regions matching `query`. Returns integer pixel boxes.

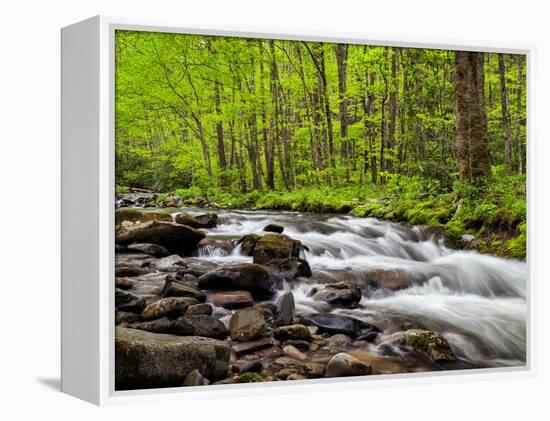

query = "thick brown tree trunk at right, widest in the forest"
[454,51,491,181]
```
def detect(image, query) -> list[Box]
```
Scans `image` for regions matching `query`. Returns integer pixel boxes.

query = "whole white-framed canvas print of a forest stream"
[62,17,531,403]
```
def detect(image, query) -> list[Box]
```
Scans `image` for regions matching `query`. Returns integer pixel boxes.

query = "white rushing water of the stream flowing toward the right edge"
[190,210,527,367]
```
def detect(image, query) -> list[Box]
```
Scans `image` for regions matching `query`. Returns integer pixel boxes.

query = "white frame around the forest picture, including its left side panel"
[61,16,537,405]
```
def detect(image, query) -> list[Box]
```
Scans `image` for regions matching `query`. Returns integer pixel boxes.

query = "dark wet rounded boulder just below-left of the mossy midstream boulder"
[198,263,274,295]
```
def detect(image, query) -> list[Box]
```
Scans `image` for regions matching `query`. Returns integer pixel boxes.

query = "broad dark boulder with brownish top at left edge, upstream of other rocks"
[116,221,206,255]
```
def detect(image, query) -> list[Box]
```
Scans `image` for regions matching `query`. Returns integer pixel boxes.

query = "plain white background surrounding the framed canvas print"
[0,0,550,421]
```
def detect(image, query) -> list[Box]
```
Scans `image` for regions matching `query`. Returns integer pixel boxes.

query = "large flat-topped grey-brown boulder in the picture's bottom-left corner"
[115,327,230,390]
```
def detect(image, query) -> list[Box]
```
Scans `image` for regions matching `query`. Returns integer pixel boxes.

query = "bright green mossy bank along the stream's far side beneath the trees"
[117,167,527,259]
